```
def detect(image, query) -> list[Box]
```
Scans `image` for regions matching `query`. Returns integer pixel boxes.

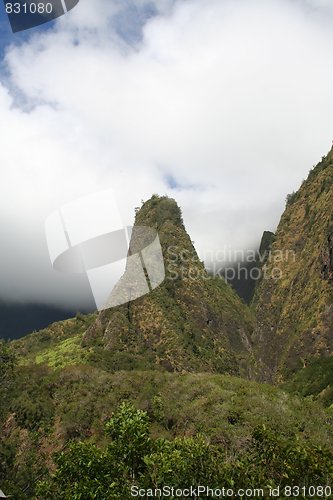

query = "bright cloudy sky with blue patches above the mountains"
[0,0,333,308]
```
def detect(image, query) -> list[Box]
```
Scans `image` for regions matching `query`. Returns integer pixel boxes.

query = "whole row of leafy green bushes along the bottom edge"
[37,403,333,500]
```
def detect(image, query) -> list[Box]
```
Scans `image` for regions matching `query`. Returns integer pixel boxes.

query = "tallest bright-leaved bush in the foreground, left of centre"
[37,402,151,500]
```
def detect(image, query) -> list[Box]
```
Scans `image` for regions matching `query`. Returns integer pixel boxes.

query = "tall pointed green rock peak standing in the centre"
[84,195,253,374]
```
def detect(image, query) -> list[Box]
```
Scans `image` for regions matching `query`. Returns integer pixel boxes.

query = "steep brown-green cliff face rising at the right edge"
[253,149,333,382]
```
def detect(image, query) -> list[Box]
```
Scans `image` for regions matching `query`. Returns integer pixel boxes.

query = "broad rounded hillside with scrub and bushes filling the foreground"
[0,346,333,500]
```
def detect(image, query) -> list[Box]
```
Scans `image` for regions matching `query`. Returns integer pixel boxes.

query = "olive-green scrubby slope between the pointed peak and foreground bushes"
[0,366,333,500]
